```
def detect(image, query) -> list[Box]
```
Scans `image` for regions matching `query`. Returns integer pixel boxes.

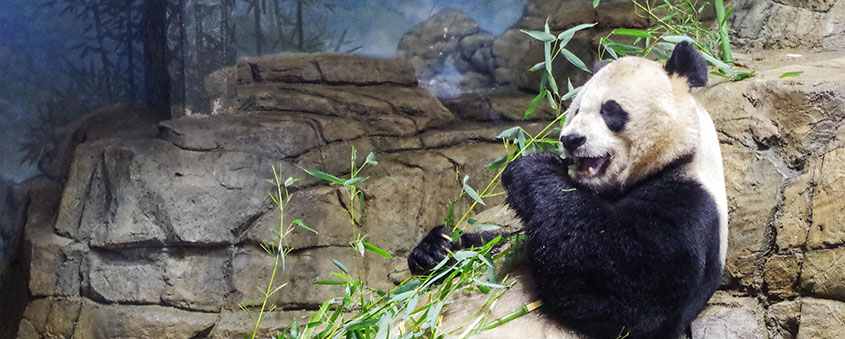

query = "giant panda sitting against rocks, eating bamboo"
[408,42,727,339]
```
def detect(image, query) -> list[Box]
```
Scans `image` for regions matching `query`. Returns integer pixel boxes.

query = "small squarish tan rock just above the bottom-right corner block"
[801,247,845,301]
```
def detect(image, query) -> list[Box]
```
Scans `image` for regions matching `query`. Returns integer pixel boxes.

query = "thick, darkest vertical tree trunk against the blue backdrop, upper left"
[141,0,171,120]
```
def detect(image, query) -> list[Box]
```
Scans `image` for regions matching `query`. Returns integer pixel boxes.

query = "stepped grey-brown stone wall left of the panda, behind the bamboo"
[9,55,552,338]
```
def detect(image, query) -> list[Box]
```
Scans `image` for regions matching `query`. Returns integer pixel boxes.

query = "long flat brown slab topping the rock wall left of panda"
[238,53,417,86]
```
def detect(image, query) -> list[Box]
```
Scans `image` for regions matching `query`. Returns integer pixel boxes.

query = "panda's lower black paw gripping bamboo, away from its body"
[408,226,501,275]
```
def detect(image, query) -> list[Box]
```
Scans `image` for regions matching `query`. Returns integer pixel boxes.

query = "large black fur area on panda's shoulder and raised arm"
[502,153,722,339]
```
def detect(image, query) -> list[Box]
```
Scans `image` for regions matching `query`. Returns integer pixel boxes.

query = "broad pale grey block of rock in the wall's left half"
[56,140,280,248]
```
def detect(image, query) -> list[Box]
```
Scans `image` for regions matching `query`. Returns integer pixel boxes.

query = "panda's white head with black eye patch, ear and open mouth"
[560,42,707,193]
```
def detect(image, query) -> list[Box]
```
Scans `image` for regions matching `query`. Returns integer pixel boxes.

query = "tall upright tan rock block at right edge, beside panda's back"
[807,148,845,249]
